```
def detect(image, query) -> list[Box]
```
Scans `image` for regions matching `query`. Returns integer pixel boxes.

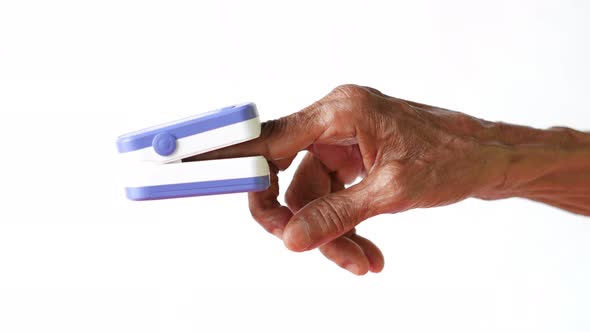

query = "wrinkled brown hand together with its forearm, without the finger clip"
[190,85,590,275]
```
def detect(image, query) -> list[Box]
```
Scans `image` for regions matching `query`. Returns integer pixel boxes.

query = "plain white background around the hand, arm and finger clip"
[0,0,590,332]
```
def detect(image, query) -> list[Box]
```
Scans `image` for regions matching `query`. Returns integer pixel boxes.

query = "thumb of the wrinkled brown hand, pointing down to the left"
[283,177,386,251]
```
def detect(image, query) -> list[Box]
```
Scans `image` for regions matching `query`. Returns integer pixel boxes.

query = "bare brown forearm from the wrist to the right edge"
[475,123,590,216]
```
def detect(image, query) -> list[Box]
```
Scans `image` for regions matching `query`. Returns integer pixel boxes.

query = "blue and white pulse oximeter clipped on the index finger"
[117,103,270,200]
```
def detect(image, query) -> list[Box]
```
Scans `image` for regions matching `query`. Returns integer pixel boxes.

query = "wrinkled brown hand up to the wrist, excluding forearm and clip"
[192,85,506,275]
